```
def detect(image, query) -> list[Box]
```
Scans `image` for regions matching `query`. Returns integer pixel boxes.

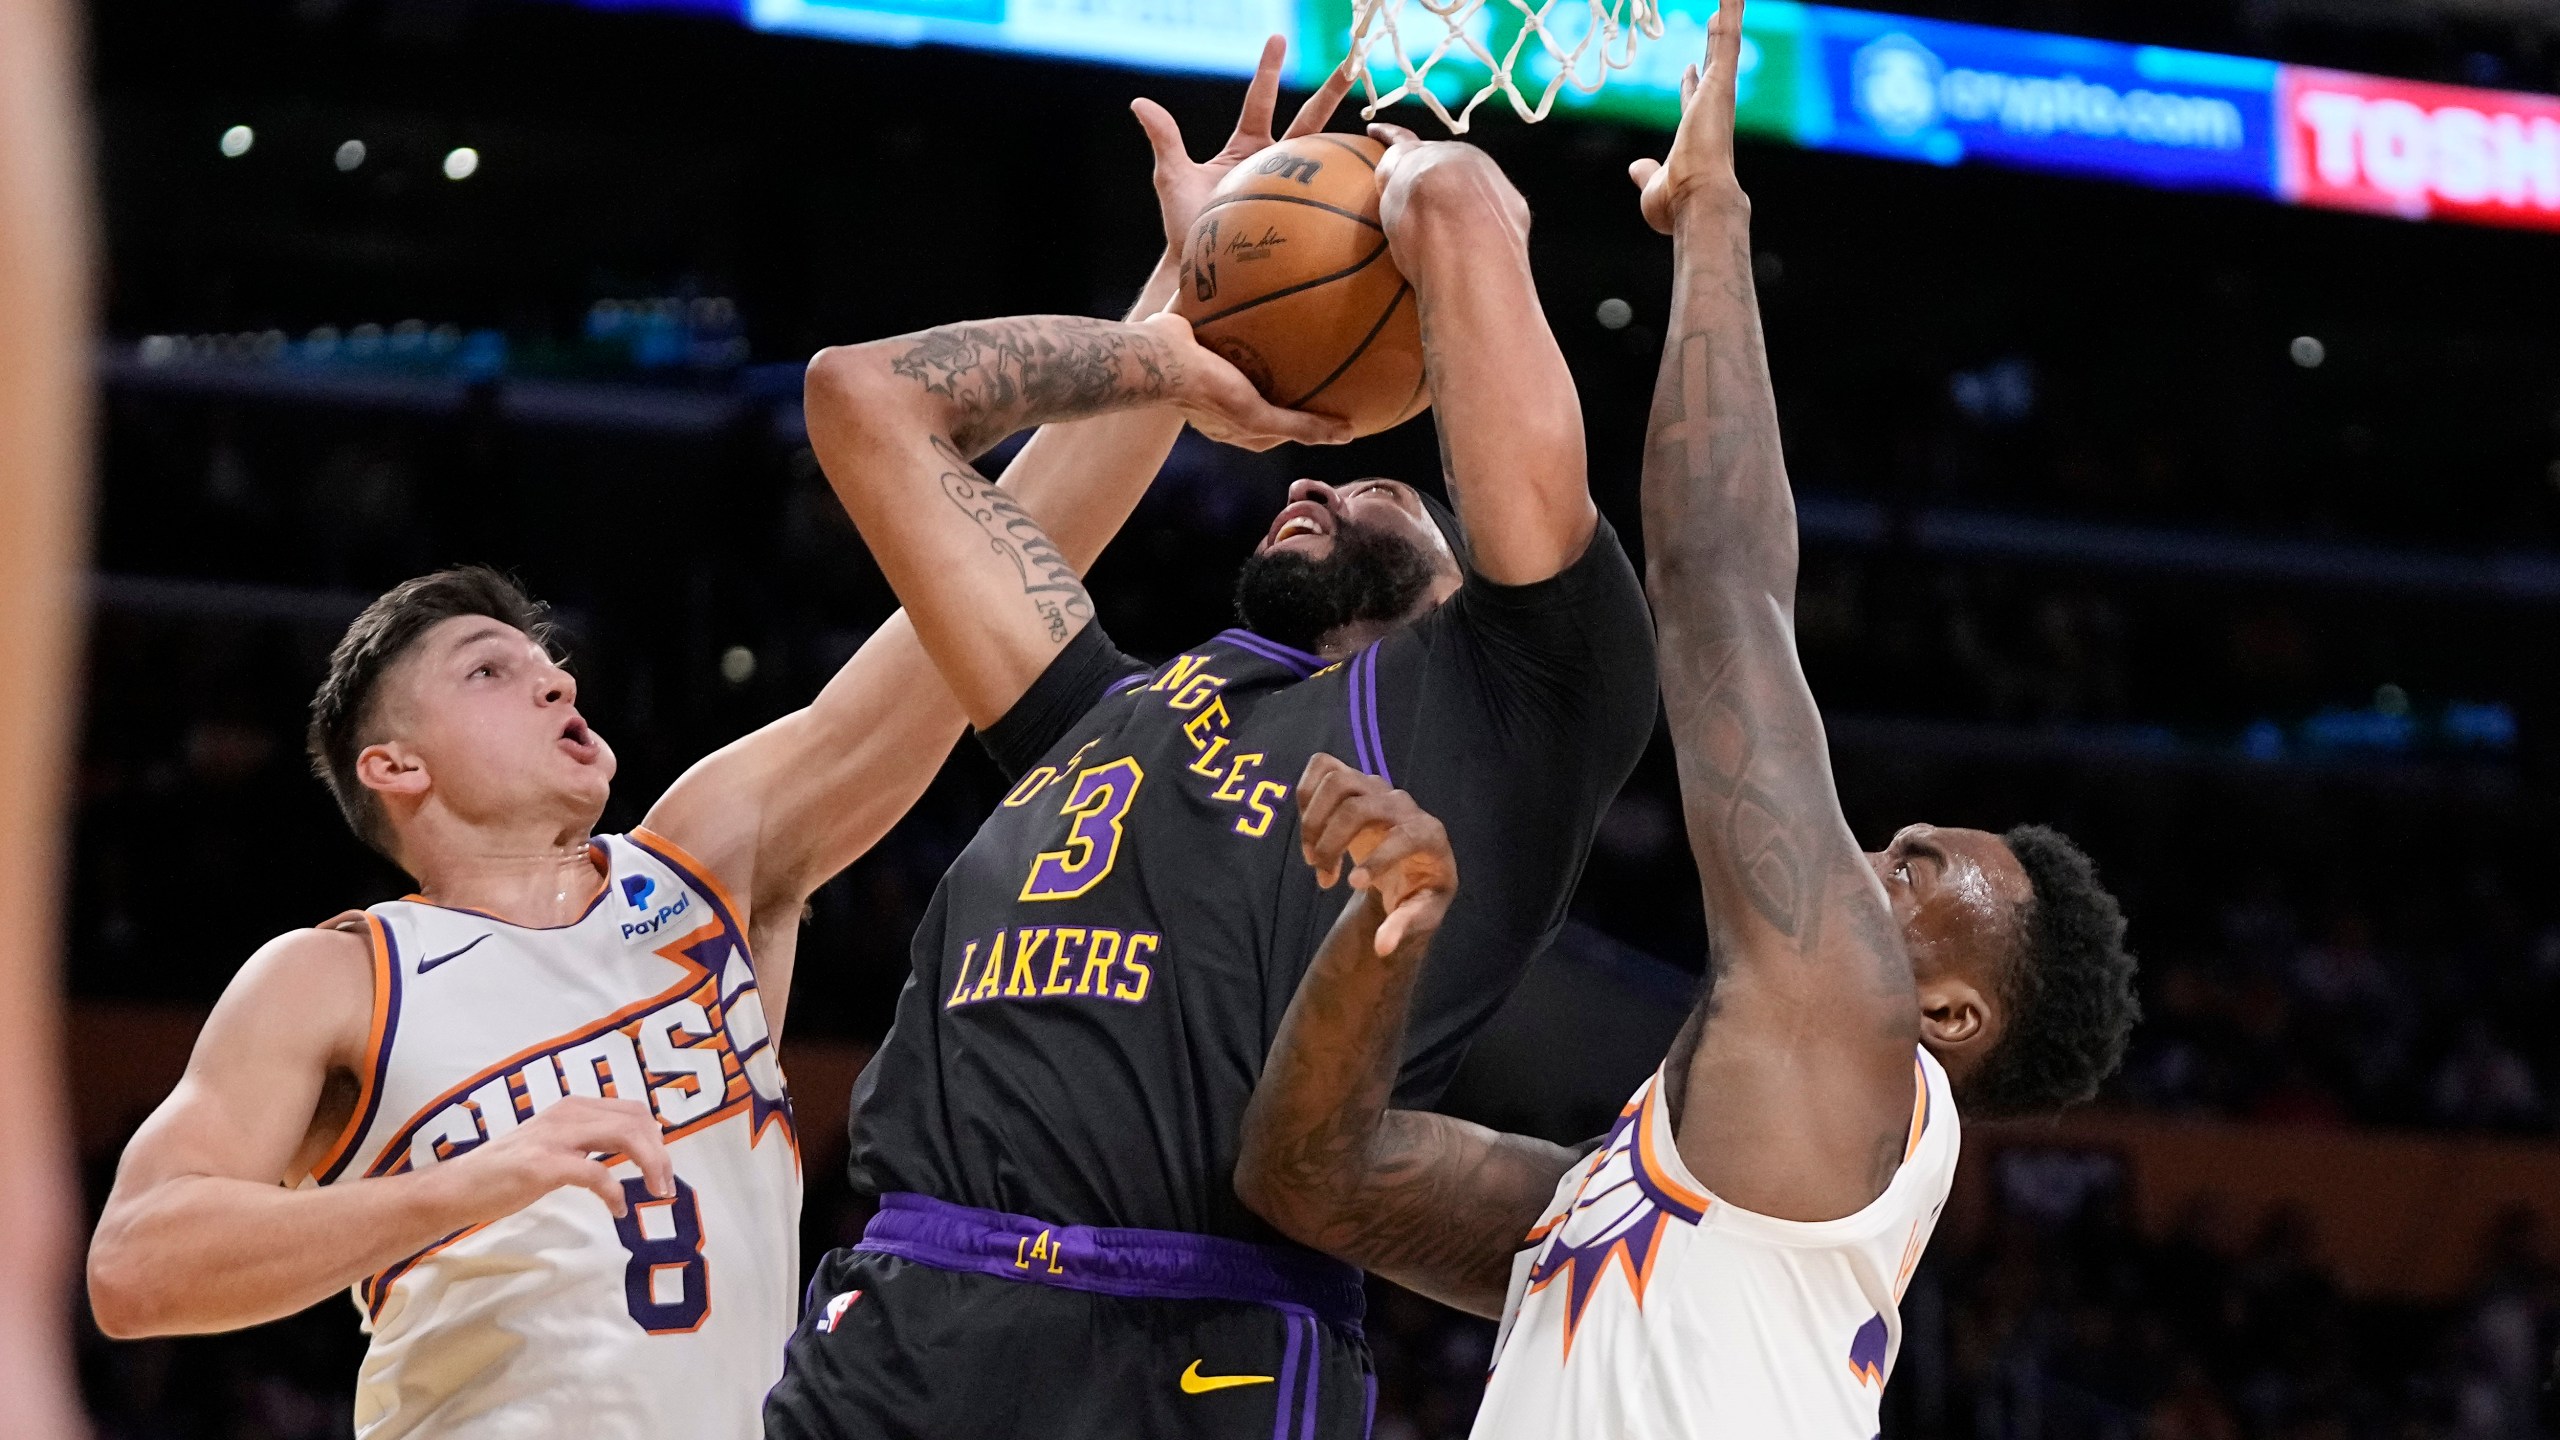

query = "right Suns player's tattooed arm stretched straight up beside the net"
[1633,0,1920,1220]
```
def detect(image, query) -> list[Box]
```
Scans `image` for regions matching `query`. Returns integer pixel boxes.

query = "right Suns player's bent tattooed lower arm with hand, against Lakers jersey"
[1236,756,1577,1317]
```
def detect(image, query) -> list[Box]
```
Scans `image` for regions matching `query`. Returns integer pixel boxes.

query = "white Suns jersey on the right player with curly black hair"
[1475,1051,1956,1440]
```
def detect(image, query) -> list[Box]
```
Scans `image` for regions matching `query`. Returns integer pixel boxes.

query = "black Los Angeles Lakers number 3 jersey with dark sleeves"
[852,520,1654,1240]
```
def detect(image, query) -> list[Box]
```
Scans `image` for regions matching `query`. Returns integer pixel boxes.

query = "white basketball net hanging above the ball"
[1352,0,1661,136]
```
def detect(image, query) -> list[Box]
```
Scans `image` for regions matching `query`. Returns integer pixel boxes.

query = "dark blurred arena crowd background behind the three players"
[67,0,2560,1440]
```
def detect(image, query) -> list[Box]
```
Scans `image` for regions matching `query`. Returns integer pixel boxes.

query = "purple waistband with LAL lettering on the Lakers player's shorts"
[855,1191,1367,1332]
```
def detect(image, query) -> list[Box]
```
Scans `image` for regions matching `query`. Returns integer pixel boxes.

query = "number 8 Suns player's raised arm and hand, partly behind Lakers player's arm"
[648,36,1349,1014]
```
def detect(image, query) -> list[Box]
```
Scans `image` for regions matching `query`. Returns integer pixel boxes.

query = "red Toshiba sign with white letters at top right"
[2278,67,2560,231]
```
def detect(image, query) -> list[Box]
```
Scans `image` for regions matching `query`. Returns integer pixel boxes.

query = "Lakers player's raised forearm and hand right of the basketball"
[1370,126,1600,584]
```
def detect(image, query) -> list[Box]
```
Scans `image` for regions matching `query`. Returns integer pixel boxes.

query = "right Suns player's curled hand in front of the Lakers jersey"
[1298,753,1457,956]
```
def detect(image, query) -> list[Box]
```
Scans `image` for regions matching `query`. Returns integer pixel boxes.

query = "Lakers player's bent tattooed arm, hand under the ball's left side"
[806,315,1344,728]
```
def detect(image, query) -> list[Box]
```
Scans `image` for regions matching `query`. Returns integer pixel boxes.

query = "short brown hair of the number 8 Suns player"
[305,566,550,861]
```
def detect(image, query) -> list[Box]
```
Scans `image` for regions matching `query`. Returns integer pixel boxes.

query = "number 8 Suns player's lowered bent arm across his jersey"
[90,930,676,1338]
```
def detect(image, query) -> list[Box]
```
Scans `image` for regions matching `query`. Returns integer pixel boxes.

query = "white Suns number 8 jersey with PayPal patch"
[312,830,801,1440]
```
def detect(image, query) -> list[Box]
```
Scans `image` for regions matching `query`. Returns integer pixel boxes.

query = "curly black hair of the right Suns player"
[1964,825,2143,1117]
